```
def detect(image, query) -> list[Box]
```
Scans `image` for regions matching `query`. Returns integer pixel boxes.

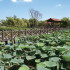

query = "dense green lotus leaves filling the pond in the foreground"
[0,30,70,70]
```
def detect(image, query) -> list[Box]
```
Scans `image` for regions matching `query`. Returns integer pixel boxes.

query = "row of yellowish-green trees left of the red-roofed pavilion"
[1,16,43,29]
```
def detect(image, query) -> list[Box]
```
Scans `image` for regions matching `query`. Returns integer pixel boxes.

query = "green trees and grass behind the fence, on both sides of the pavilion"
[0,15,70,30]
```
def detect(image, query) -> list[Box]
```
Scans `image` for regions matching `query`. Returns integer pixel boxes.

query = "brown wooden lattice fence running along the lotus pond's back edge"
[0,28,69,42]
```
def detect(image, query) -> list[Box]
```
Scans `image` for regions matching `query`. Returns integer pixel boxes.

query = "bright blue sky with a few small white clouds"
[0,0,70,20]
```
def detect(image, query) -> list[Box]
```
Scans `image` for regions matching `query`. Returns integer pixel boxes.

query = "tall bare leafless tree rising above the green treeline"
[30,9,42,27]
